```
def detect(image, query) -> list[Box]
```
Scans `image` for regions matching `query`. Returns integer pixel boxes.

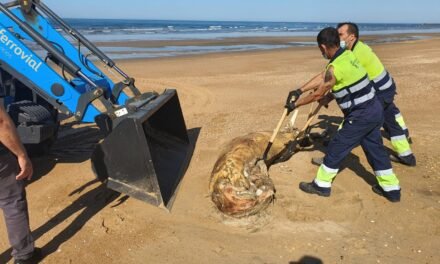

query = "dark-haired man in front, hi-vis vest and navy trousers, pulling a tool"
[286,27,401,202]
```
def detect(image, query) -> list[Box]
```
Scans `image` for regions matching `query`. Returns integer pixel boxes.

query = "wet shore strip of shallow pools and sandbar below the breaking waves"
[87,33,440,60]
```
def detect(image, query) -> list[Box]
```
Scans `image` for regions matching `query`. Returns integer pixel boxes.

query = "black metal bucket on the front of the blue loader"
[91,90,193,210]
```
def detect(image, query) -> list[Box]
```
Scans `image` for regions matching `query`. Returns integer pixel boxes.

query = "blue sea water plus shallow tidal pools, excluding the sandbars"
[51,19,440,59]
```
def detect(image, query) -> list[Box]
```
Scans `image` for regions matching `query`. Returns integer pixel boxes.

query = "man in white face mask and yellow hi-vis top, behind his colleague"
[337,22,416,166]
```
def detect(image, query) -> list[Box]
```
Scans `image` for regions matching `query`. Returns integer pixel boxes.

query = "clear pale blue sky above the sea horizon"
[43,0,440,23]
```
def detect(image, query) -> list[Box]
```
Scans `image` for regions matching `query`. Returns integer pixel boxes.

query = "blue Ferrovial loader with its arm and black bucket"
[0,0,193,209]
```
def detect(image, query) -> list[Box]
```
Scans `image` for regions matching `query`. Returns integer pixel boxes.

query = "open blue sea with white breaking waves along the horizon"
[57,19,440,41]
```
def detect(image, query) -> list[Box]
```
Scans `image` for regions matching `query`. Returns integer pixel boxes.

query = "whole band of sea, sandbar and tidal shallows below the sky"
[57,19,440,60]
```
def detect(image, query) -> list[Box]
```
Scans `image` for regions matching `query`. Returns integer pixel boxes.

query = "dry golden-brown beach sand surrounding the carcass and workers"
[0,37,440,264]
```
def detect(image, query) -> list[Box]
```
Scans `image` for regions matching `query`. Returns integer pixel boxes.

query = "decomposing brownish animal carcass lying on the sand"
[209,132,297,217]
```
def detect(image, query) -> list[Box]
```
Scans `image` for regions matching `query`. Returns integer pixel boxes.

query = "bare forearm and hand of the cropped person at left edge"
[0,105,33,180]
